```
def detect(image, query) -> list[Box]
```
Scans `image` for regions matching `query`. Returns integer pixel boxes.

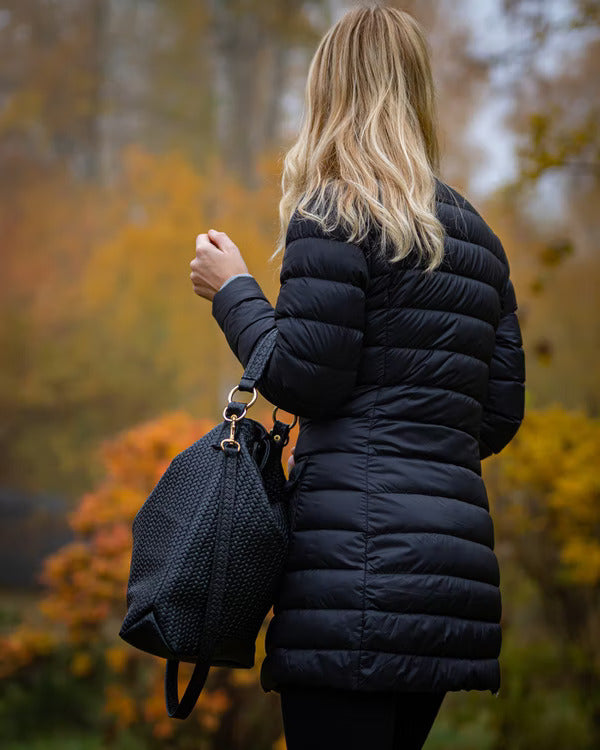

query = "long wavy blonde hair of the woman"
[271,6,444,270]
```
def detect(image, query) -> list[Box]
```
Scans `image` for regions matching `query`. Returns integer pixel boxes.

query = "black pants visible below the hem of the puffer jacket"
[280,686,446,750]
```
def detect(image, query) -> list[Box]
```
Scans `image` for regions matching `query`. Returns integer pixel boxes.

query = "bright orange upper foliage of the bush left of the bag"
[35,412,211,643]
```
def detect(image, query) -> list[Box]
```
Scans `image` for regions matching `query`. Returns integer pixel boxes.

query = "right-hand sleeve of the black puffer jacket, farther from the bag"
[479,270,525,459]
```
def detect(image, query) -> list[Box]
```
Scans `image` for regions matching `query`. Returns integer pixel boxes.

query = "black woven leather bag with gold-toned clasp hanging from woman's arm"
[119,329,297,719]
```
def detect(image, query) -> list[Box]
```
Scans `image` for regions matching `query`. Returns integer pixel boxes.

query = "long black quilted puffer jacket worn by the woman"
[212,182,525,692]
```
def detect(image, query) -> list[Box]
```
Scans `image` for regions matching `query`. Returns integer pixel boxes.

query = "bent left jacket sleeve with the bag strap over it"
[212,221,368,418]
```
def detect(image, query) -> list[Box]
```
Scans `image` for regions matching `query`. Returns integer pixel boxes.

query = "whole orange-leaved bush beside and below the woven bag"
[0,411,290,739]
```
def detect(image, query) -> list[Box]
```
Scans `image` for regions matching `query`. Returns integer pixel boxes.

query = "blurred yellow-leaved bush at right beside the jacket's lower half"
[484,404,600,748]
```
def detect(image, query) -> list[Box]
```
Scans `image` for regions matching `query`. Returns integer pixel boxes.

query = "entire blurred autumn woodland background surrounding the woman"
[0,0,600,750]
